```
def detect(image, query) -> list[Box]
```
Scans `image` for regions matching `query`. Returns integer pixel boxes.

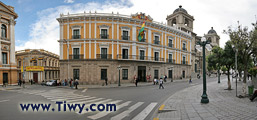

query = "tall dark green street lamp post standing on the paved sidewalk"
[198,37,210,103]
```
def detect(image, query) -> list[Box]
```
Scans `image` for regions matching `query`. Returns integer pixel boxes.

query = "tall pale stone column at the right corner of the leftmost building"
[10,18,16,65]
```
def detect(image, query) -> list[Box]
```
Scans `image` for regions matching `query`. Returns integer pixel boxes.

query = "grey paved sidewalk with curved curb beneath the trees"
[154,79,257,120]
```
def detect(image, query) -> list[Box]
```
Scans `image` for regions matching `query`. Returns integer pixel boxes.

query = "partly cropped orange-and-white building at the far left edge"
[0,1,18,85]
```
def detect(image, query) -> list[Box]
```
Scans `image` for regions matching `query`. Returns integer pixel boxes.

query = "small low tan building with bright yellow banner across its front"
[16,49,60,83]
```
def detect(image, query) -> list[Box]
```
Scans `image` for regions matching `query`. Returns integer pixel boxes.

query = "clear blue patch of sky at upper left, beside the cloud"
[2,0,109,46]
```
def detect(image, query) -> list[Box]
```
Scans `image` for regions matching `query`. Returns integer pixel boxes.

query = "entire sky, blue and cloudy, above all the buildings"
[1,0,257,54]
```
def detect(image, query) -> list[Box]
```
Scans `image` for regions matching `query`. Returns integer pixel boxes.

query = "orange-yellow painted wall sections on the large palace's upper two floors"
[62,18,191,63]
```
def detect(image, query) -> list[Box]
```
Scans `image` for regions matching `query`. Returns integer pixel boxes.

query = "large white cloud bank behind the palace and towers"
[16,0,257,54]
